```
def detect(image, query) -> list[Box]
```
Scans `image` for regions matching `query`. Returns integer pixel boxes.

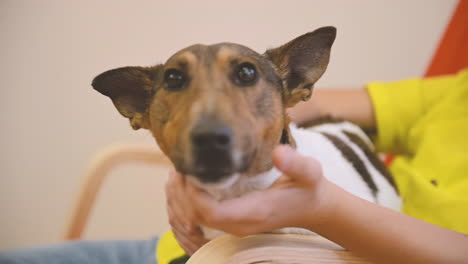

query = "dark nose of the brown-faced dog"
[191,121,232,151]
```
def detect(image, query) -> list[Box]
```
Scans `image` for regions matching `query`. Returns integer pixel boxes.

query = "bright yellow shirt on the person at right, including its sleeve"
[367,69,468,233]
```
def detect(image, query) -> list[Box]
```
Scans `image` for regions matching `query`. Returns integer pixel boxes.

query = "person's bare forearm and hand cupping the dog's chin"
[169,146,468,263]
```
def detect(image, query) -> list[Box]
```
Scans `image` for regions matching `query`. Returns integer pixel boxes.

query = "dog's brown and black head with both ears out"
[92,27,336,183]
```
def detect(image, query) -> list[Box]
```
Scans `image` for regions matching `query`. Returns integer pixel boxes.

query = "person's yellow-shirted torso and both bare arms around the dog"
[166,70,468,263]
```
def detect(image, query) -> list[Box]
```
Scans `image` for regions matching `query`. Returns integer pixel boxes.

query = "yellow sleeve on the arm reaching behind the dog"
[367,75,456,153]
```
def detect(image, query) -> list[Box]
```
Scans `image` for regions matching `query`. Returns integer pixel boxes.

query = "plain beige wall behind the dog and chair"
[0,0,456,249]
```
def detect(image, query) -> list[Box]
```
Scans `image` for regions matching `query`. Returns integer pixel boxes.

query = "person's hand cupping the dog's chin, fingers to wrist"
[165,146,333,240]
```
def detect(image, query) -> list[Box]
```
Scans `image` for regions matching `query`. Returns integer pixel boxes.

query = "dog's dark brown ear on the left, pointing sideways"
[92,65,162,130]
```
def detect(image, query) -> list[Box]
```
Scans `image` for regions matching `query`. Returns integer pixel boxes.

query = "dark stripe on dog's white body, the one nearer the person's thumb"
[320,132,378,197]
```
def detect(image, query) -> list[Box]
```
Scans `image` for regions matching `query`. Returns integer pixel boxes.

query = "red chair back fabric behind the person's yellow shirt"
[384,0,468,166]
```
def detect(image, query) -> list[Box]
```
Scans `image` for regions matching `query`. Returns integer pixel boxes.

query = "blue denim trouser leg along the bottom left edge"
[0,238,157,264]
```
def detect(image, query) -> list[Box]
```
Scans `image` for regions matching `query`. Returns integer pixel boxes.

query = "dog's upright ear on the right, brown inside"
[265,27,336,107]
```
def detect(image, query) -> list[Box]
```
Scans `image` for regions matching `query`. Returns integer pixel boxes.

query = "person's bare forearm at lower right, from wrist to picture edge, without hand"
[305,174,468,263]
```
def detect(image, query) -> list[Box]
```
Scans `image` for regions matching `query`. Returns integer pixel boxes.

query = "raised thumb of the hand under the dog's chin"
[273,145,322,184]
